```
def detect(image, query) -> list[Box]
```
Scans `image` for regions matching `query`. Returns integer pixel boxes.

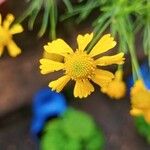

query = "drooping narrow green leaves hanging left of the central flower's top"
[18,0,57,39]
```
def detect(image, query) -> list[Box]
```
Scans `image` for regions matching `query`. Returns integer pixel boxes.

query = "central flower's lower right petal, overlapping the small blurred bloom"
[92,69,114,87]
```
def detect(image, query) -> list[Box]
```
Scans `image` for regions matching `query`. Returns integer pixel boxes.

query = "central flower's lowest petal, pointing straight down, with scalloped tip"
[74,79,94,98]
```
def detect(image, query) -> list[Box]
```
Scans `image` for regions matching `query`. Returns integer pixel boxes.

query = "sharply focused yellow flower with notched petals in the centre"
[40,33,124,98]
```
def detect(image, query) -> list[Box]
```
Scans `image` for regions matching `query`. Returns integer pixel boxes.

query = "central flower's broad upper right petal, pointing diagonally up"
[90,34,116,57]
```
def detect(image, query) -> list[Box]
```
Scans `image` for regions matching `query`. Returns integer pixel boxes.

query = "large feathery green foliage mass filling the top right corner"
[62,0,150,80]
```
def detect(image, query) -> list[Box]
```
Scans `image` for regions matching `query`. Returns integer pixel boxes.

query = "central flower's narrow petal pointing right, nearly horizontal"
[96,53,125,66]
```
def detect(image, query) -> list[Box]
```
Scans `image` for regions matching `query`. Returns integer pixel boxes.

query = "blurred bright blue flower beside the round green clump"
[31,88,67,136]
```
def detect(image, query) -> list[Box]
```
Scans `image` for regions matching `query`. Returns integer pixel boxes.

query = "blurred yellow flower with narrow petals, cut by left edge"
[0,14,23,57]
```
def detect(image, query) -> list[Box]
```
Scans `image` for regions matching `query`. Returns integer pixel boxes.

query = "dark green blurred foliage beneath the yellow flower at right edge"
[135,116,150,144]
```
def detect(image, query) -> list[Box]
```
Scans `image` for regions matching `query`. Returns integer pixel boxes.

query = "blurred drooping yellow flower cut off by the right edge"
[130,80,150,123]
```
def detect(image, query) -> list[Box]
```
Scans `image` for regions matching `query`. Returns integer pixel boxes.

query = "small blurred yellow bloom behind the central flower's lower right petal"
[101,70,126,99]
